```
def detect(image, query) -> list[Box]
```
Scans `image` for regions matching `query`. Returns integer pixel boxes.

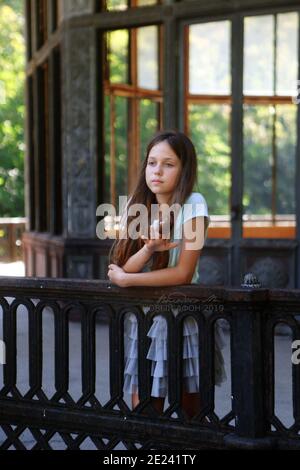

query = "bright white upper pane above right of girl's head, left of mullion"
[189,21,231,95]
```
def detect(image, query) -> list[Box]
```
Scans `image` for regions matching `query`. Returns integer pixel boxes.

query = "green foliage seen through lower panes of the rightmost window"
[243,105,296,215]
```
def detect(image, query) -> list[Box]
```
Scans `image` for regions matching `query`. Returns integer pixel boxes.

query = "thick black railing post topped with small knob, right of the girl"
[229,275,271,448]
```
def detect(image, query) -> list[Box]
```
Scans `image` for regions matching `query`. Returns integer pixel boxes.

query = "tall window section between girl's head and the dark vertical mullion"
[184,20,231,238]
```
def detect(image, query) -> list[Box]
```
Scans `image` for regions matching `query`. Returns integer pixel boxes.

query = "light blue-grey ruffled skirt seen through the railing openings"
[123,307,226,397]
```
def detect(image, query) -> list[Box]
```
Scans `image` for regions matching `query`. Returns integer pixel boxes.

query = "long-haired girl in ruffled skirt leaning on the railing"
[108,131,225,417]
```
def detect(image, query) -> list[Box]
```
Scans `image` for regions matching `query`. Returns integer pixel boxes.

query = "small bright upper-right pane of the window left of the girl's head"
[137,26,159,90]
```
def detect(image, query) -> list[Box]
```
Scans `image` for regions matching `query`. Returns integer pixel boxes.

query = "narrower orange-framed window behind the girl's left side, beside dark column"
[103,26,162,206]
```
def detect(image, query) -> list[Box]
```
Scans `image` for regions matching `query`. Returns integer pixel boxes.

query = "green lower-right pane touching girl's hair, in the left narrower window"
[140,99,159,161]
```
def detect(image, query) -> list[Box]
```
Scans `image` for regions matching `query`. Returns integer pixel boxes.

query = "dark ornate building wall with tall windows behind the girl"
[23,0,300,288]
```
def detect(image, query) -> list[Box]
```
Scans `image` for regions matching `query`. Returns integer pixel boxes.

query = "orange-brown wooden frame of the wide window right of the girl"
[179,6,300,240]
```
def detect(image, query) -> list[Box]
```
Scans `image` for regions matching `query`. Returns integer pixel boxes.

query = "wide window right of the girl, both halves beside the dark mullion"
[184,12,299,238]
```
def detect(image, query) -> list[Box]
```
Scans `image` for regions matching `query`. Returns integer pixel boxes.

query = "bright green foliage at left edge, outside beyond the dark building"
[0,0,25,217]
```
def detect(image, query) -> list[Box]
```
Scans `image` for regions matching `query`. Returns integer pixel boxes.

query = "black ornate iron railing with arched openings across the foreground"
[0,278,300,450]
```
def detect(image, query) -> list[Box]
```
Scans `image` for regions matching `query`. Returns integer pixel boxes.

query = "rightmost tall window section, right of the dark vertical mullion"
[243,12,299,238]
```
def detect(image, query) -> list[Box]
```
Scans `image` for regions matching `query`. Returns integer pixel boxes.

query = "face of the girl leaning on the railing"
[146,141,182,200]
